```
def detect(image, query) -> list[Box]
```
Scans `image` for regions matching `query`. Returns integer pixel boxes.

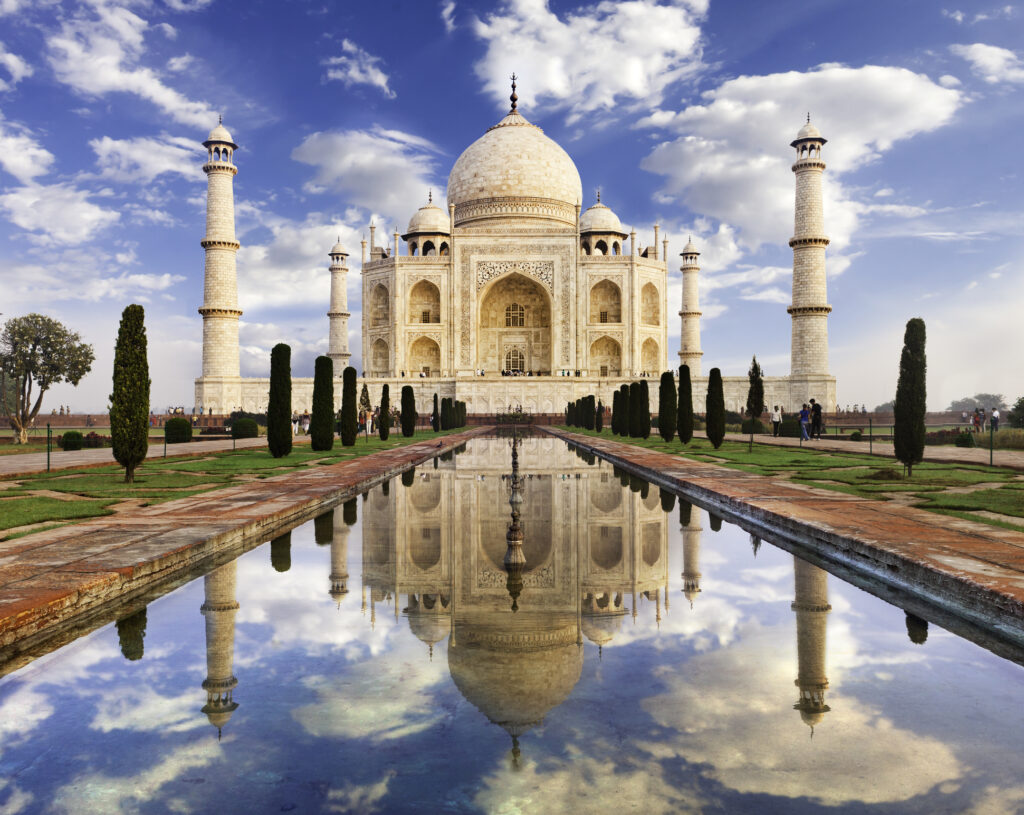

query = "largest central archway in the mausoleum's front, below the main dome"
[476,272,552,373]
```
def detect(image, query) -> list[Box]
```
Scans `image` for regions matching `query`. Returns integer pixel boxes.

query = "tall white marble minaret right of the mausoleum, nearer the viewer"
[786,114,835,410]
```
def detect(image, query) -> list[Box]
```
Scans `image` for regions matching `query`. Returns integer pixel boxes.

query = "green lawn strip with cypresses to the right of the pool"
[563,428,1024,530]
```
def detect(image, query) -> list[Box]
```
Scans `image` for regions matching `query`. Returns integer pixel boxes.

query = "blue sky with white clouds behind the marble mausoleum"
[0,0,1024,412]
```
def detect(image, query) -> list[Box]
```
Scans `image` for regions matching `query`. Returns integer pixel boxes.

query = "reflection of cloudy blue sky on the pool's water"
[0,442,1024,813]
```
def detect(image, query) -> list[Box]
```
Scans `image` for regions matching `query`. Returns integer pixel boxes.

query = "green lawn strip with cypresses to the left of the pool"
[0,423,460,540]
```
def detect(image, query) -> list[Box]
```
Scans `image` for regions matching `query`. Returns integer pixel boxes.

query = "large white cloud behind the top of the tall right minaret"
[639,65,964,251]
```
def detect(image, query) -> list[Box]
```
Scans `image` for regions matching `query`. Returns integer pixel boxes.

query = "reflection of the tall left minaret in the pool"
[200,560,239,738]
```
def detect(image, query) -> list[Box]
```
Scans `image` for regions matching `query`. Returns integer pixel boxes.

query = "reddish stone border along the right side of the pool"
[541,427,1024,660]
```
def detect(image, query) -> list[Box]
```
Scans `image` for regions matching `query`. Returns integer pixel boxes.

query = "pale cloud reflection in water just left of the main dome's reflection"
[292,660,447,741]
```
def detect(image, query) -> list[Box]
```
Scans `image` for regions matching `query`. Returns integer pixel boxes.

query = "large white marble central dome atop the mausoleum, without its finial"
[447,110,583,226]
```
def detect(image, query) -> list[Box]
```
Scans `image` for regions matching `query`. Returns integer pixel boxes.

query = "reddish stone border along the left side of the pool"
[0,427,492,676]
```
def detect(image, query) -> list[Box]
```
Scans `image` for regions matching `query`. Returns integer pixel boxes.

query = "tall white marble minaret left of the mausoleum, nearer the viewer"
[196,119,242,413]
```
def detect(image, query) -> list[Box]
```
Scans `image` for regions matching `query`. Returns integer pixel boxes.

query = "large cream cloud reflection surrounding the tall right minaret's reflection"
[643,626,963,805]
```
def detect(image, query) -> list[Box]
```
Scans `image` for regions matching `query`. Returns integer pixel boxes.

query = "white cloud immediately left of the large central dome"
[292,127,443,220]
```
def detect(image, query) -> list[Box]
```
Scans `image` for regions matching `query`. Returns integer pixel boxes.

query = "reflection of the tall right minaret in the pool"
[792,557,831,736]
